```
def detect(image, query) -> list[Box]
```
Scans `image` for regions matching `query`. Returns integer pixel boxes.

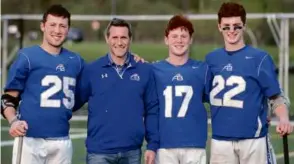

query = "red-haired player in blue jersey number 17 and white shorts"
[153,15,210,164]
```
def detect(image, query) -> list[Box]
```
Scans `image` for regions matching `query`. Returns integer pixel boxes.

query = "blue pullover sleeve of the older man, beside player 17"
[144,70,159,152]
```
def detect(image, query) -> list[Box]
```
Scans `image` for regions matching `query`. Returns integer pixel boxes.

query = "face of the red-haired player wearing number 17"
[165,27,192,56]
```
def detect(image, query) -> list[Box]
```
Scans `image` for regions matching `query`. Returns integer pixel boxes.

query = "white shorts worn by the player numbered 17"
[156,148,206,164]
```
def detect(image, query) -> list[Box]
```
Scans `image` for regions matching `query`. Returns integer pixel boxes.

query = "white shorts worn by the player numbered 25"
[12,137,73,164]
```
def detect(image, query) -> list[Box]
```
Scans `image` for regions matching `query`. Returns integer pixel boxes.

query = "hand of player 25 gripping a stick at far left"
[9,120,28,137]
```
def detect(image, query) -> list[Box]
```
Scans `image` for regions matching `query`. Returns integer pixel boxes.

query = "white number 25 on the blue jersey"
[41,75,76,109]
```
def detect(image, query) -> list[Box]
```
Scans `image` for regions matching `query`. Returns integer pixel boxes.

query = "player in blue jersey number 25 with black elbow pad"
[1,5,83,164]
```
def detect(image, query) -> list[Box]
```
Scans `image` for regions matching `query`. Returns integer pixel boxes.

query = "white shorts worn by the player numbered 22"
[210,137,276,164]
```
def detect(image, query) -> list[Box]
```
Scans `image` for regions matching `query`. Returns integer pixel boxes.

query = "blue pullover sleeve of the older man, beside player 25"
[73,60,91,111]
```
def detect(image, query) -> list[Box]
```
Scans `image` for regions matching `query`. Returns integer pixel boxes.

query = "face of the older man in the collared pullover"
[105,26,131,57]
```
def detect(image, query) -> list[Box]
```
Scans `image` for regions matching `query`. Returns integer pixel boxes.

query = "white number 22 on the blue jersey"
[210,75,246,108]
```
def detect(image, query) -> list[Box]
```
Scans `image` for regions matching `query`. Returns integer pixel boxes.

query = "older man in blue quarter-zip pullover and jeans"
[75,19,159,164]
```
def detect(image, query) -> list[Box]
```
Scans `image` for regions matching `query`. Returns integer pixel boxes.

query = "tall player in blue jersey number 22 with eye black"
[206,2,293,164]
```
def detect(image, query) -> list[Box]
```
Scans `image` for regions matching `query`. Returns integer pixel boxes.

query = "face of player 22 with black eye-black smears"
[218,17,245,44]
